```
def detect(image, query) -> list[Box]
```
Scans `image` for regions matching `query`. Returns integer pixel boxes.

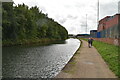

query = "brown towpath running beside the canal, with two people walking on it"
[56,40,116,78]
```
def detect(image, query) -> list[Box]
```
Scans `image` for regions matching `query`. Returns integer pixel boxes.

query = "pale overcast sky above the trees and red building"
[13,0,119,34]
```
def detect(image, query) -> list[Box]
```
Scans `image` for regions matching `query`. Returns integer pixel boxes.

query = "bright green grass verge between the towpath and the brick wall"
[80,39,120,78]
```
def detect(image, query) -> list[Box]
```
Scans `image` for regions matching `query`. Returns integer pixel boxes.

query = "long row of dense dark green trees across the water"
[2,2,68,41]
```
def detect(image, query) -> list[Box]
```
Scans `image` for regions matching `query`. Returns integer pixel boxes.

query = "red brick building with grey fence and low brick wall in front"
[95,14,120,45]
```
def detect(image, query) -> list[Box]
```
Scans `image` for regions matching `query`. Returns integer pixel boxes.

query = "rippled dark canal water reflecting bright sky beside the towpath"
[2,38,80,78]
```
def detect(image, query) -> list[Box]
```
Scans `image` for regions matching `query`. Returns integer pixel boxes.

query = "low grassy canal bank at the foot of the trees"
[2,38,63,46]
